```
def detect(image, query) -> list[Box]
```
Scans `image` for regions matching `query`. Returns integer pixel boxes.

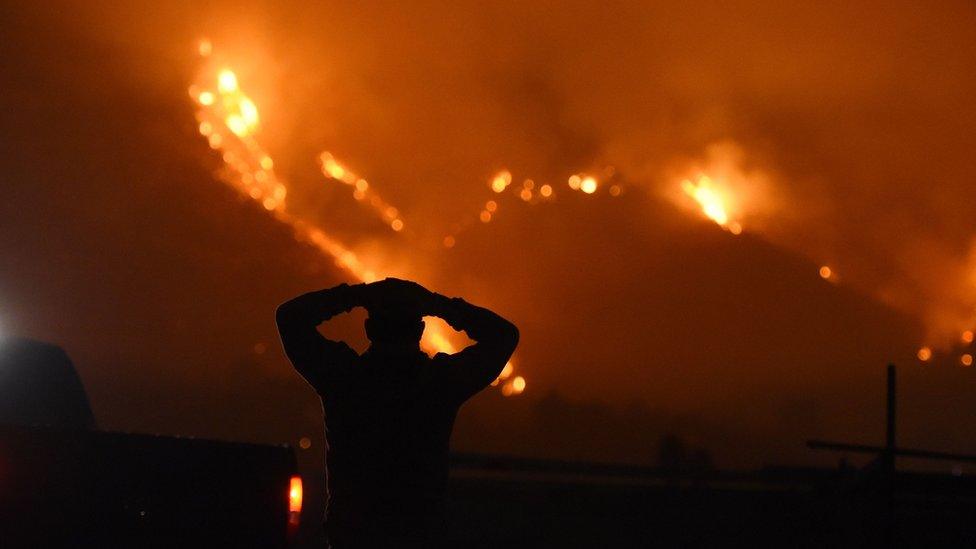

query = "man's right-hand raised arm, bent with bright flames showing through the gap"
[426,293,519,401]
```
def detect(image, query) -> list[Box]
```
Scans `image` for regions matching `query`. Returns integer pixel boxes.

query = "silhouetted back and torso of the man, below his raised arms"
[320,352,461,510]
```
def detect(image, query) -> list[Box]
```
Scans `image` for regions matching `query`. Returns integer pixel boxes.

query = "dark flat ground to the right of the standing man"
[449,456,976,547]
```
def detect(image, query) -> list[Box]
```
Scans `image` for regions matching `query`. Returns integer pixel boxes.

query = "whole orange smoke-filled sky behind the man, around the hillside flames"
[0,2,976,465]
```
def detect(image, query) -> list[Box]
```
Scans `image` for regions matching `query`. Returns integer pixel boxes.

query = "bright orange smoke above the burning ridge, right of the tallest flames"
[216,2,976,344]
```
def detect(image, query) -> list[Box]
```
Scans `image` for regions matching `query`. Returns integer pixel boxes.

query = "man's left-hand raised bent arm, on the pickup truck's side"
[275,284,366,393]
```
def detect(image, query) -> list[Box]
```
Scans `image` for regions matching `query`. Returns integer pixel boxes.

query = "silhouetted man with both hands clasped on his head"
[277,278,518,549]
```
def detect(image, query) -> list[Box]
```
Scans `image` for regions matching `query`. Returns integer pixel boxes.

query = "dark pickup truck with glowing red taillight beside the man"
[0,339,302,548]
